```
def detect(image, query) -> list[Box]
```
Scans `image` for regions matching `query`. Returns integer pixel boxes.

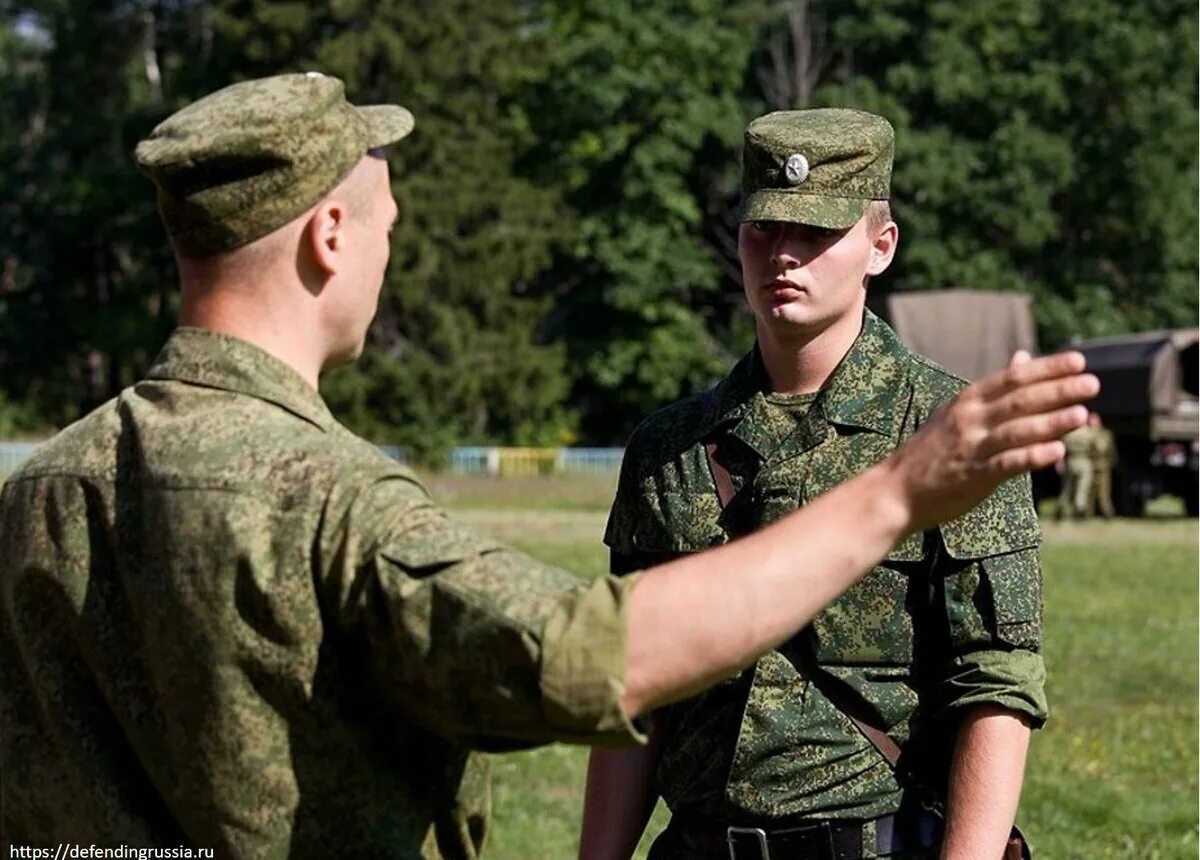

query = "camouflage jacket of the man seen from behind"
[0,329,632,860]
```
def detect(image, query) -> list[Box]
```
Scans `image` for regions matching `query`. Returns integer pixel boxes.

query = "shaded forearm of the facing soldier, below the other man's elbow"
[580,730,661,860]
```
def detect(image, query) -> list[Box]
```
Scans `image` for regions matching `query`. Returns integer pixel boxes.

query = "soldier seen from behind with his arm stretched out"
[0,73,1097,860]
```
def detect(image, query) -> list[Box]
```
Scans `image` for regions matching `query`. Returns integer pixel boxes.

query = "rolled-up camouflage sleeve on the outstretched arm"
[323,475,644,747]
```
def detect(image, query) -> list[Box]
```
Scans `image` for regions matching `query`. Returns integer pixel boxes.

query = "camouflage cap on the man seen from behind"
[134,72,413,257]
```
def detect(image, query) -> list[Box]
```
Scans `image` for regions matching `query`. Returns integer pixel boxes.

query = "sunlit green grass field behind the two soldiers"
[430,477,1198,860]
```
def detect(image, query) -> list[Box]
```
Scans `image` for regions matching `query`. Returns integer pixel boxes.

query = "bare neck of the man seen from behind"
[179,284,323,390]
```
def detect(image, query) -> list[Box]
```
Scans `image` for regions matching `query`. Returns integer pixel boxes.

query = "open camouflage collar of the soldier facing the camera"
[706,311,911,435]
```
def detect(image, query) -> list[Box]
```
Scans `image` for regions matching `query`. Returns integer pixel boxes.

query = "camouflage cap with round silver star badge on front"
[742,108,895,230]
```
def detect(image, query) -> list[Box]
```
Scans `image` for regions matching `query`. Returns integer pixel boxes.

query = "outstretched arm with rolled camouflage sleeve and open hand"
[328,353,1098,745]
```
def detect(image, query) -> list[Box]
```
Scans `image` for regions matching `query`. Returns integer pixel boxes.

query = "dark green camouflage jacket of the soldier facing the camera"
[605,313,1046,820]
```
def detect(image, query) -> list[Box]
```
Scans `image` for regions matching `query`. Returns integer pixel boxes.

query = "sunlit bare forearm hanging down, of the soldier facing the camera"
[941,705,1030,860]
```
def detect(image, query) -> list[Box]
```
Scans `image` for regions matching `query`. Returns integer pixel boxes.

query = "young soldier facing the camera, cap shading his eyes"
[581,109,1046,860]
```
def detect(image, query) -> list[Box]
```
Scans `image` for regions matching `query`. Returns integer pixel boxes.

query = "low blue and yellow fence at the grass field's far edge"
[0,441,625,476]
